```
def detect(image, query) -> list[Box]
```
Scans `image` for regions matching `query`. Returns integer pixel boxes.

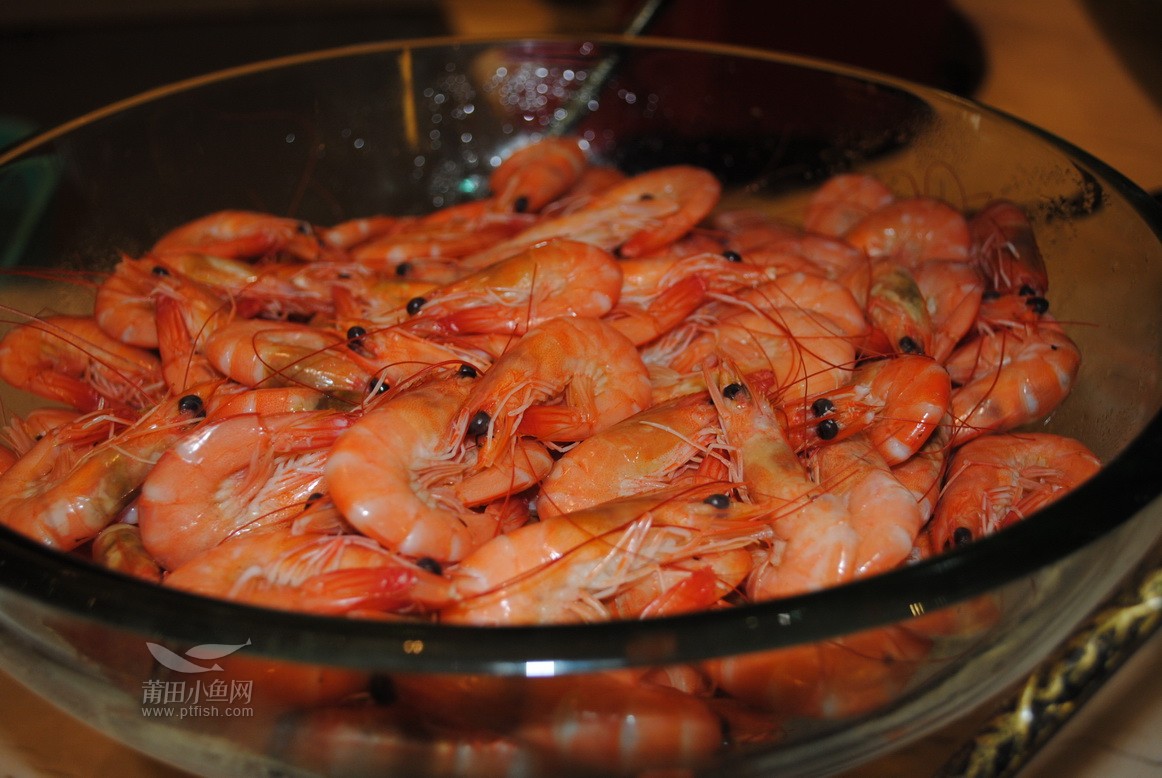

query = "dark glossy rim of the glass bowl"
[0,35,1162,675]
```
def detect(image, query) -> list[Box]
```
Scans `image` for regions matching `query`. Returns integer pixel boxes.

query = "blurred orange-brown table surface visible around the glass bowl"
[0,0,1162,778]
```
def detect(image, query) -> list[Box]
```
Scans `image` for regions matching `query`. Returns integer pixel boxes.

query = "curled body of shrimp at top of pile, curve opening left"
[581,165,722,257]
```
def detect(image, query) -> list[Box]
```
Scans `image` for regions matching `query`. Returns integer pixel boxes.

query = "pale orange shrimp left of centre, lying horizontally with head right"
[203,319,372,395]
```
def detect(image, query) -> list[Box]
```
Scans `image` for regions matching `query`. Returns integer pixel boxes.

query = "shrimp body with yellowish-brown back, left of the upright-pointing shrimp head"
[537,392,718,518]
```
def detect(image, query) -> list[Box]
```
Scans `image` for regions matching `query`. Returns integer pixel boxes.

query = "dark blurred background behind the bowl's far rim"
[0,0,984,146]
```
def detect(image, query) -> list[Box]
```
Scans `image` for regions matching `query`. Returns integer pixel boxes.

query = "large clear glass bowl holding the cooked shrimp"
[0,37,1162,776]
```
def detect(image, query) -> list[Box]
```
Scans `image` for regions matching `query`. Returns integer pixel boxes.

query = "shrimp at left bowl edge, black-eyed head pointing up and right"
[0,394,205,550]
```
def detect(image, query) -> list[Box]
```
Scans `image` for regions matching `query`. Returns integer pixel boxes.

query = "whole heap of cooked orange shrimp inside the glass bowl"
[0,138,1099,625]
